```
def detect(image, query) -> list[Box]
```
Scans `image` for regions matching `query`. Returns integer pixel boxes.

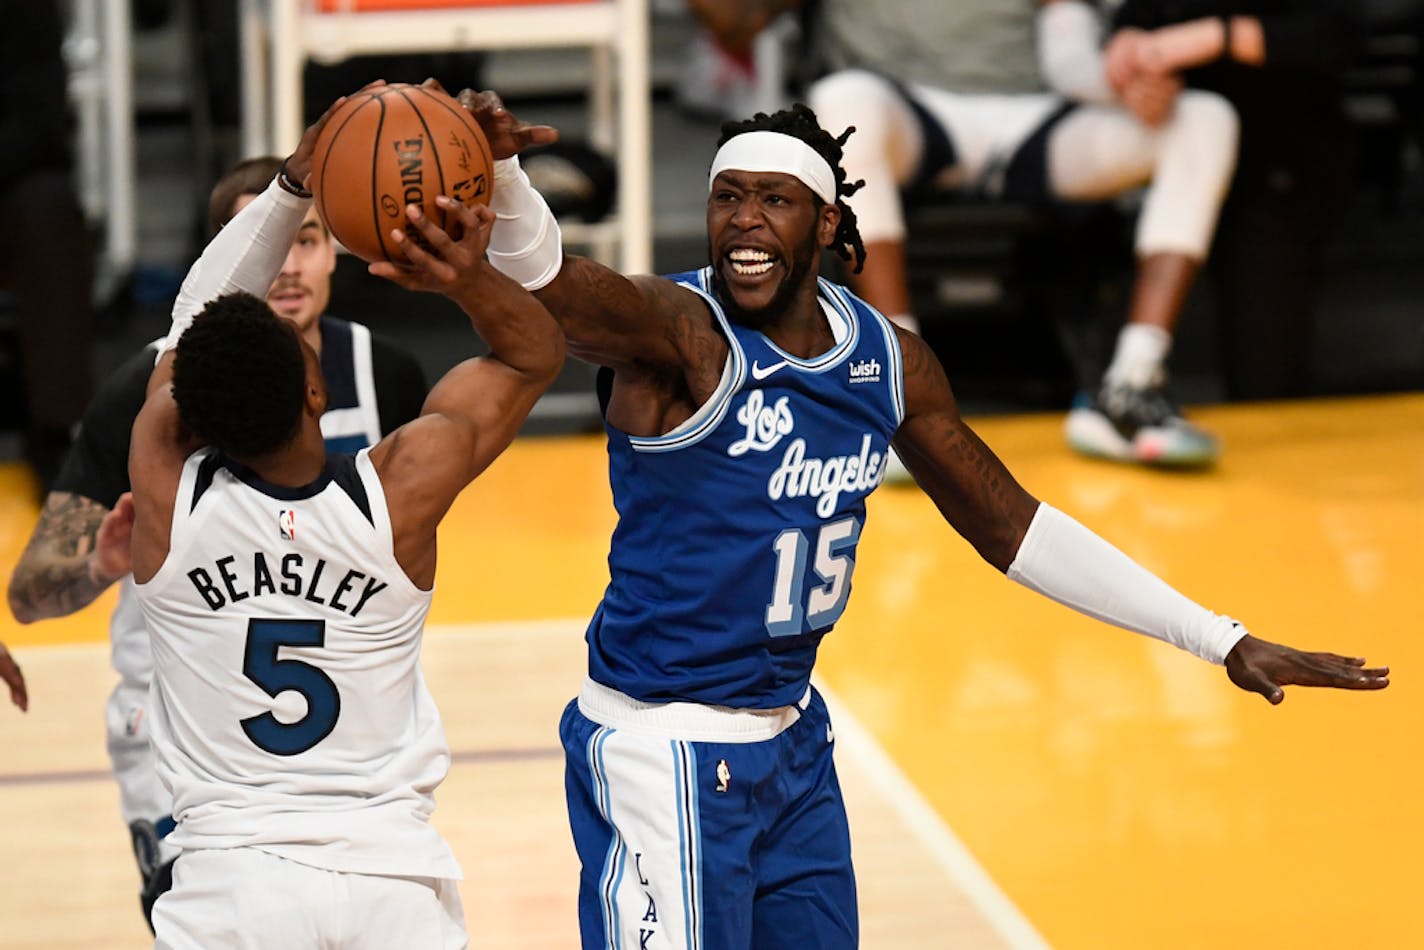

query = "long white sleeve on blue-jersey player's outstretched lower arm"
[1008,504,1246,664]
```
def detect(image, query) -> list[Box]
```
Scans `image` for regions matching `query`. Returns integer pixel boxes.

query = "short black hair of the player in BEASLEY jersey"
[174,293,306,460]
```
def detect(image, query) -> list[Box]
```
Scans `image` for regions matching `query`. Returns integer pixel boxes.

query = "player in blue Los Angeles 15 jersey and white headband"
[438,91,1387,950]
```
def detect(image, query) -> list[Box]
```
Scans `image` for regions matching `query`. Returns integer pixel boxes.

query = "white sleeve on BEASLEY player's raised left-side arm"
[158,181,312,356]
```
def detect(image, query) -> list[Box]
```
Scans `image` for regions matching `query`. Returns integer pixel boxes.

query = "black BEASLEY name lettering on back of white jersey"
[188,551,386,617]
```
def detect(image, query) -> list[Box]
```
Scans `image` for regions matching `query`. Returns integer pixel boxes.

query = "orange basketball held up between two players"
[310,83,494,263]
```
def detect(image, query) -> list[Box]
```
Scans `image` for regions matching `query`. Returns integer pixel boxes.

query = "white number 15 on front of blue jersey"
[766,517,860,637]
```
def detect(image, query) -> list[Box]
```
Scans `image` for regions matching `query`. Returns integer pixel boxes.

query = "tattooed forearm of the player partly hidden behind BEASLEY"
[10,491,112,622]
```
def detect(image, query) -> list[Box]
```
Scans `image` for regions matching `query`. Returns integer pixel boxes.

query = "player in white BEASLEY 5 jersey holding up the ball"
[130,92,564,950]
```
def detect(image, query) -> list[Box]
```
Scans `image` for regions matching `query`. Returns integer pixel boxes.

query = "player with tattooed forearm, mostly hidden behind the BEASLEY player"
[0,157,426,919]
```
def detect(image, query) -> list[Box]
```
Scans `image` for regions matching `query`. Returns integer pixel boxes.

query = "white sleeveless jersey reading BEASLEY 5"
[137,450,460,877]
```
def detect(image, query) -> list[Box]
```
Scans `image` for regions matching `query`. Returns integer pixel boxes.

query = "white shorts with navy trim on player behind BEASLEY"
[104,681,178,929]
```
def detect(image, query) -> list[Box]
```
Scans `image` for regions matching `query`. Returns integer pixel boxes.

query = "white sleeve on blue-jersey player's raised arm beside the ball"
[486,157,564,291]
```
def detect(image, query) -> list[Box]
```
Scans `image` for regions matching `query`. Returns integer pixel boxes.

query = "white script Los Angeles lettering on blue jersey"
[726,390,884,518]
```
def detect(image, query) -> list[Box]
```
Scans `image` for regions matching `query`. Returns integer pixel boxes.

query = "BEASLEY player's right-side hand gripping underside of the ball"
[367,203,494,299]
